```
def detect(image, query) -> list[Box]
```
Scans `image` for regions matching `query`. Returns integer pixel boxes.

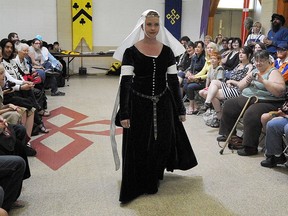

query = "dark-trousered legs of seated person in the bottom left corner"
[0,154,26,212]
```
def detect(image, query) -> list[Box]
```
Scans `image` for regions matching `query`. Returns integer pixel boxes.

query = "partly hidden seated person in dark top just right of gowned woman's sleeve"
[177,41,195,84]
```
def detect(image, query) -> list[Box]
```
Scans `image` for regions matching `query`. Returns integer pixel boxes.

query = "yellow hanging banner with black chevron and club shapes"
[72,0,93,51]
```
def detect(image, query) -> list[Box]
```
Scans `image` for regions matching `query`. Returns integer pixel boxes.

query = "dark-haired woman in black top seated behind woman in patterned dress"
[221,38,242,71]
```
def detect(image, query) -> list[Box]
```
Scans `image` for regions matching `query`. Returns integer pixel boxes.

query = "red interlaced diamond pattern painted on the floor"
[32,107,122,170]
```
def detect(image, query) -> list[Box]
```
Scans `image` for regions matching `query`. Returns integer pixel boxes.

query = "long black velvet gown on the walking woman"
[120,45,197,203]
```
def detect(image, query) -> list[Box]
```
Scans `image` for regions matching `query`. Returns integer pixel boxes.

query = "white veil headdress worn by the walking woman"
[113,9,185,61]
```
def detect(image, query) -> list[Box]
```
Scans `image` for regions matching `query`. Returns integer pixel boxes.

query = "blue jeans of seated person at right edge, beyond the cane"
[265,117,288,155]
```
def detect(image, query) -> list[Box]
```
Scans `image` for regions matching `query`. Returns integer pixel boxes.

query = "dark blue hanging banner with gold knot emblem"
[165,0,182,39]
